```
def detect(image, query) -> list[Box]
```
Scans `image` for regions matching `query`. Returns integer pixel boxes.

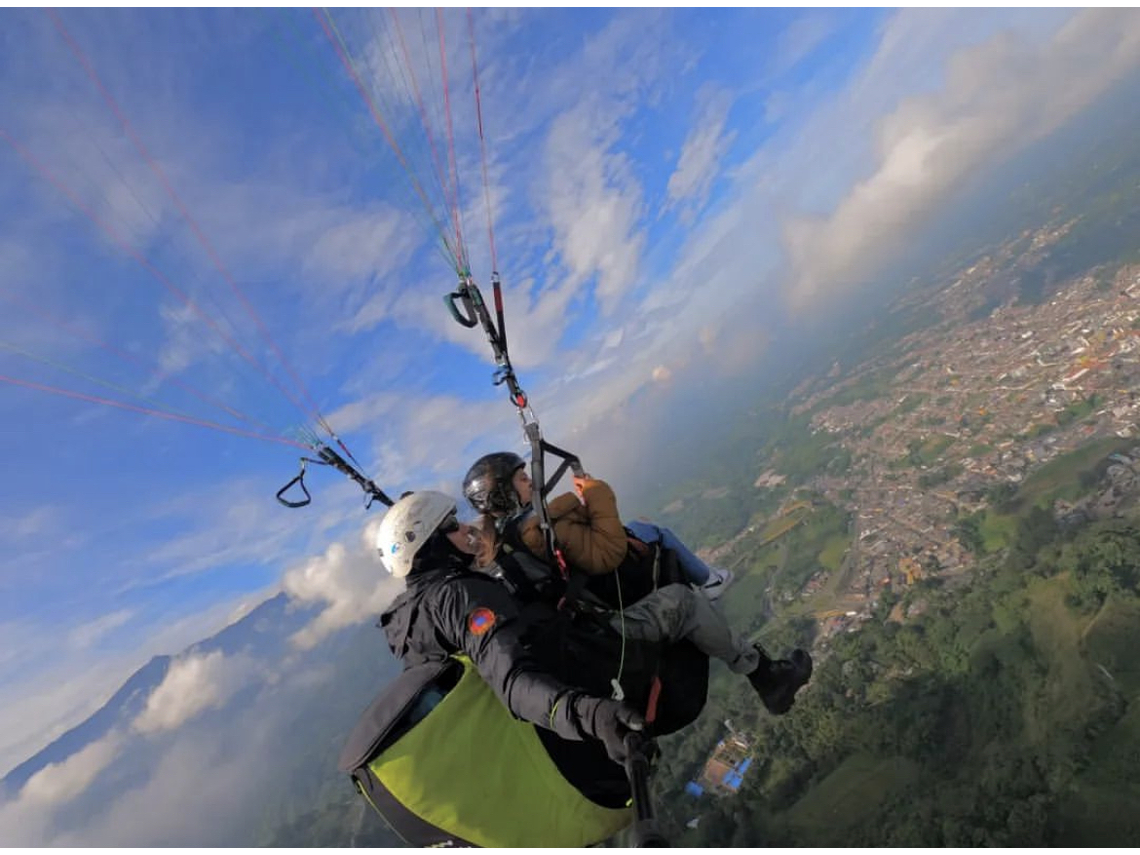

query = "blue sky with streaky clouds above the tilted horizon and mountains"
[0,9,1140,798]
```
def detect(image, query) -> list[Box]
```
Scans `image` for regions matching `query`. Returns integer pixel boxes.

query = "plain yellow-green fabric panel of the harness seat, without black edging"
[369,657,634,848]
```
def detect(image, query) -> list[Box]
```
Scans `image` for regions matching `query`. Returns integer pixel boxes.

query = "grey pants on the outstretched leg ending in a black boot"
[610,585,760,674]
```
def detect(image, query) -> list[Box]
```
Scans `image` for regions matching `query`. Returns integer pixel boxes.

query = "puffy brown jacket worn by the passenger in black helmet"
[519,478,628,576]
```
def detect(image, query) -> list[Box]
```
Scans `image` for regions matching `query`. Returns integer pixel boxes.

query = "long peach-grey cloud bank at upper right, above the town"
[785,9,1140,304]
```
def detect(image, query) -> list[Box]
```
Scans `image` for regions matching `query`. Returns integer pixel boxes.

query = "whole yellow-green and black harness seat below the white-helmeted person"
[340,656,635,848]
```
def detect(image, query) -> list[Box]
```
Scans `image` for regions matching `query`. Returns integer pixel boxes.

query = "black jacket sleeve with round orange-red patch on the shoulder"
[433,577,585,740]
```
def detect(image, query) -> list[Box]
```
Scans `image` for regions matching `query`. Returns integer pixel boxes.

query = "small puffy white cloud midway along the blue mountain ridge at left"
[132,650,254,734]
